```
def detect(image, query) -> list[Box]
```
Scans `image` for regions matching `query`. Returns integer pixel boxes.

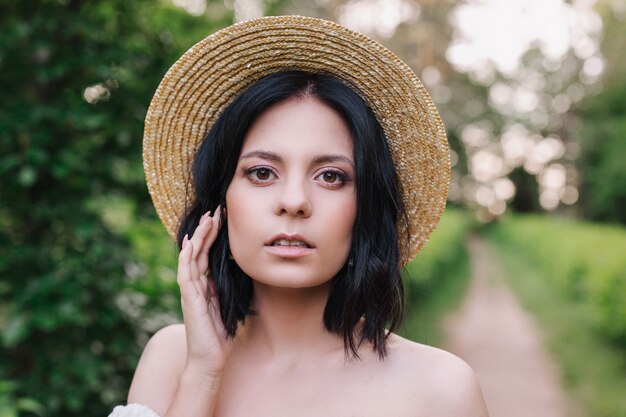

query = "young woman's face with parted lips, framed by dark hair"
[226,97,356,288]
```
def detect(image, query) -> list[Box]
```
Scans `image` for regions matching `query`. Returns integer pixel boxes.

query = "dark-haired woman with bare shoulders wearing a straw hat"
[112,16,487,417]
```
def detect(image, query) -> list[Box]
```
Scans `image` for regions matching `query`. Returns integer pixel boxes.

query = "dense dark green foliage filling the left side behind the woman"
[0,0,230,417]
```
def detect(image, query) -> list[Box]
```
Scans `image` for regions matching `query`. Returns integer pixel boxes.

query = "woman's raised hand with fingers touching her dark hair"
[177,207,233,378]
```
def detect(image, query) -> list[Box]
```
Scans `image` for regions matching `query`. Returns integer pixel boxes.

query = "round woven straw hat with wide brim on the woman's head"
[143,16,450,265]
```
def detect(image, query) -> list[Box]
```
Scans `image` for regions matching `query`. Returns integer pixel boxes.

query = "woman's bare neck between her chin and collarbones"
[242,283,343,364]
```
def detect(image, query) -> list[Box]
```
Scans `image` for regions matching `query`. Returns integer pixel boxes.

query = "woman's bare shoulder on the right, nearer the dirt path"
[389,335,488,417]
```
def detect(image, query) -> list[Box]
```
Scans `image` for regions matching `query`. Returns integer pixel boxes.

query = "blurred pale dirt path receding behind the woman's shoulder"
[444,238,571,417]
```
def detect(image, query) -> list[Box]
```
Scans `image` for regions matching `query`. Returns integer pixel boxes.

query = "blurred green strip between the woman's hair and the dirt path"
[398,209,471,346]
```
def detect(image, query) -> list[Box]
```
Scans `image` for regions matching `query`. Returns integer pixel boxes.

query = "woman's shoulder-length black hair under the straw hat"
[178,71,408,359]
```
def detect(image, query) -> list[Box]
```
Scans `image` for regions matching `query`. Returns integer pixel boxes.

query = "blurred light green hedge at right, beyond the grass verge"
[488,216,626,349]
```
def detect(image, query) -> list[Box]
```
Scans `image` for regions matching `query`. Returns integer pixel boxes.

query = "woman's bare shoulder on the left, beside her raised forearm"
[128,324,187,415]
